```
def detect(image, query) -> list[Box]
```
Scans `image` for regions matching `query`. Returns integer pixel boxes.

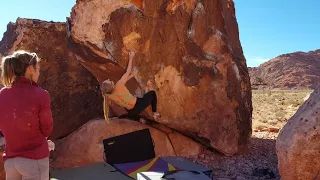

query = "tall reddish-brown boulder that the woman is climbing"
[68,0,252,155]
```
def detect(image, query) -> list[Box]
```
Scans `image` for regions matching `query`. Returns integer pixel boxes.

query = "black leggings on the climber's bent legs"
[127,91,157,120]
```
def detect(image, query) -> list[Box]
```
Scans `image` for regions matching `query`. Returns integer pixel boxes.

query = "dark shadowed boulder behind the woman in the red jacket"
[0,19,103,139]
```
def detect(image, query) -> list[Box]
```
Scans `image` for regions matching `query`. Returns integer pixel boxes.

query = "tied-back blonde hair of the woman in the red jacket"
[1,50,40,87]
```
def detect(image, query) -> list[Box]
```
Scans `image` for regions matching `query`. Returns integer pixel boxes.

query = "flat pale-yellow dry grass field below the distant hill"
[252,90,311,131]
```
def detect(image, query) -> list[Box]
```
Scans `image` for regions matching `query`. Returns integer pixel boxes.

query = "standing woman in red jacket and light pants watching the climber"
[0,51,53,180]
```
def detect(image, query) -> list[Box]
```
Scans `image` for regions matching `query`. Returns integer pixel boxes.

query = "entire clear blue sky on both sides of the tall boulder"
[0,0,320,67]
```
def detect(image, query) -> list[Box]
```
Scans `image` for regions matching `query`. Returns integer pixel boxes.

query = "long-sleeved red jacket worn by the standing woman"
[0,77,53,159]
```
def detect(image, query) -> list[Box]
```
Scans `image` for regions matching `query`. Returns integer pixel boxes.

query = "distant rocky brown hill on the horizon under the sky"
[249,49,320,89]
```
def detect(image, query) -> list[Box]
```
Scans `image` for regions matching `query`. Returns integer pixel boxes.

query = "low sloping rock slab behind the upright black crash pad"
[51,118,203,169]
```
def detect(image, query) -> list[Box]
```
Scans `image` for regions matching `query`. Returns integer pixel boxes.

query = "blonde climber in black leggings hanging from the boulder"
[101,52,160,123]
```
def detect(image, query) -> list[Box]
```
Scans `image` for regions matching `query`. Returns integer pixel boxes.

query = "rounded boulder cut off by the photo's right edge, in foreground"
[276,87,320,180]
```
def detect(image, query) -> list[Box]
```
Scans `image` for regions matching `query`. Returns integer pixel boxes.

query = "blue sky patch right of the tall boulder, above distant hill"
[234,0,320,66]
